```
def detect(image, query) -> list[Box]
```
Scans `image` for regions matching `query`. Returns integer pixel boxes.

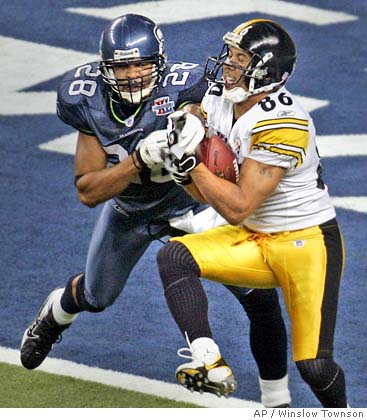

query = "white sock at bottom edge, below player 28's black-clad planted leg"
[259,374,291,407]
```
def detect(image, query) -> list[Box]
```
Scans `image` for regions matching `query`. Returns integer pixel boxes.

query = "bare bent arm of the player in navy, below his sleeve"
[75,132,138,207]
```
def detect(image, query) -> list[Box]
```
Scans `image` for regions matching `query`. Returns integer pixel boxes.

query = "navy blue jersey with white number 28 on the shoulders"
[57,62,208,219]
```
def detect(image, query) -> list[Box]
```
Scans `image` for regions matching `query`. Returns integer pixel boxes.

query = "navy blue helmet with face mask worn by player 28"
[100,14,166,105]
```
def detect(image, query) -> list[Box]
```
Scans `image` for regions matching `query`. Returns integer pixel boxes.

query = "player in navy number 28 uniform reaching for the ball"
[21,14,290,406]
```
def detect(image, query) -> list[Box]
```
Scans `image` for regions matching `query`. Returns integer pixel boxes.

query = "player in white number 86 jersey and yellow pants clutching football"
[158,19,347,407]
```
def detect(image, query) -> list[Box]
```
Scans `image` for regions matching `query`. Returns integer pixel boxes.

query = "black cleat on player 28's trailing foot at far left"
[20,289,71,369]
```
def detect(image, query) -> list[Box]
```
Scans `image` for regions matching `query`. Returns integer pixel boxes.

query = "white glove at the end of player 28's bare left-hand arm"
[136,130,169,168]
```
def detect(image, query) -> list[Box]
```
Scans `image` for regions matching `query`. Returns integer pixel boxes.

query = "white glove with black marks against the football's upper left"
[167,111,205,159]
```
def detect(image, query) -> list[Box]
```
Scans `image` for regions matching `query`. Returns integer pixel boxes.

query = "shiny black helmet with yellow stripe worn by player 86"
[205,19,296,96]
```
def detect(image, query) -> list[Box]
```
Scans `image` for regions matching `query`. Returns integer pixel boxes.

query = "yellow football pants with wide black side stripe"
[171,219,344,361]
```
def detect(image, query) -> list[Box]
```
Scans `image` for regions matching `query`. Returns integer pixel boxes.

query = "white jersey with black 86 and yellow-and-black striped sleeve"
[202,85,335,233]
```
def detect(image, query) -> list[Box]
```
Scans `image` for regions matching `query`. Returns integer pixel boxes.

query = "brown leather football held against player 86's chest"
[196,134,239,183]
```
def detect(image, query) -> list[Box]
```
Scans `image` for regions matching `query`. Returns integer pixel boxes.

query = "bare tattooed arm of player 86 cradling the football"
[191,159,285,225]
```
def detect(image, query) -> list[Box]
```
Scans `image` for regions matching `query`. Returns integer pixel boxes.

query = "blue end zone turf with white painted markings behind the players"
[0,0,367,407]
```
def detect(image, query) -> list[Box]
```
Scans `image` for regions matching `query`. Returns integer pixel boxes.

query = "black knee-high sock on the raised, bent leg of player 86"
[157,241,212,342]
